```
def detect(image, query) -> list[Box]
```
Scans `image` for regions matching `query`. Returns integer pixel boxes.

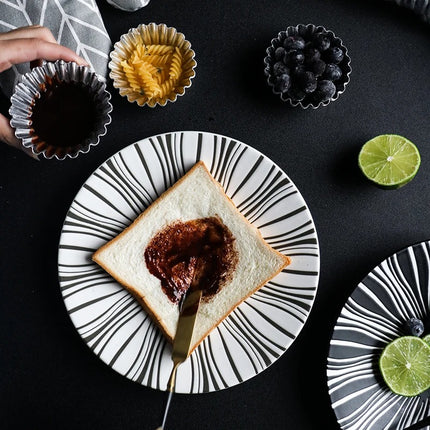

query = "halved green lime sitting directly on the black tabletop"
[358,134,421,189]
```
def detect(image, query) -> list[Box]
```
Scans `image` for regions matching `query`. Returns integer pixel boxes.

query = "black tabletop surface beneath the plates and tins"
[0,0,430,430]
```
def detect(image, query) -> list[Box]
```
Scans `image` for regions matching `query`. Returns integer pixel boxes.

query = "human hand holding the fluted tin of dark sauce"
[0,25,88,159]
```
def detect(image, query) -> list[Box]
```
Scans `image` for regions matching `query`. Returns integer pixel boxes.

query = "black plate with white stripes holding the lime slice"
[327,241,430,430]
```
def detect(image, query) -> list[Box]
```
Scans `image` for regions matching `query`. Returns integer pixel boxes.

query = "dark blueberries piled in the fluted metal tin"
[270,31,345,106]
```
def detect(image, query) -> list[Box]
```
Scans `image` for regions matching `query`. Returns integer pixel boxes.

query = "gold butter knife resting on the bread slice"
[157,288,202,430]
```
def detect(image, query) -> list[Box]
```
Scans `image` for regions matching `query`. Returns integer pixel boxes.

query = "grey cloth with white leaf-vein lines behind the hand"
[0,0,112,97]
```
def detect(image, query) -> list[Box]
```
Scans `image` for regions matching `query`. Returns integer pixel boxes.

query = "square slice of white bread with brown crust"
[93,162,290,350]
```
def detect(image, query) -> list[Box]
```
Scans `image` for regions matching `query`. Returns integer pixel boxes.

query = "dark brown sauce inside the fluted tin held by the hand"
[30,77,97,147]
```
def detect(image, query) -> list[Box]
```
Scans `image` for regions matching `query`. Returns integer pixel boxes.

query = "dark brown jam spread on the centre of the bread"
[144,217,238,303]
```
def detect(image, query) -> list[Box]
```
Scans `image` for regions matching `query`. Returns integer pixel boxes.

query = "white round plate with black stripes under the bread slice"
[58,131,320,393]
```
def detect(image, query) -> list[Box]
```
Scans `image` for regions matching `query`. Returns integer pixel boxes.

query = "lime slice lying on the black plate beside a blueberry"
[379,336,430,396]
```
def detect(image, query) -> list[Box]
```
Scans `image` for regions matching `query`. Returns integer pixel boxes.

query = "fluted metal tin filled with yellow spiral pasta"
[109,23,197,107]
